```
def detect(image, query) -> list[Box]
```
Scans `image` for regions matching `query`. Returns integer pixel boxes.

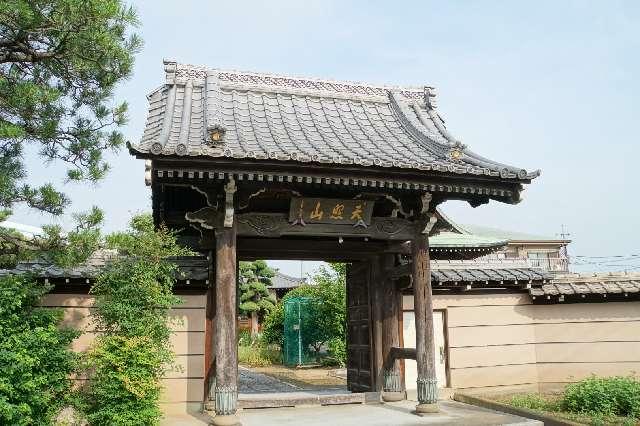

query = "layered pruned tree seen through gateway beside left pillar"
[240,260,276,318]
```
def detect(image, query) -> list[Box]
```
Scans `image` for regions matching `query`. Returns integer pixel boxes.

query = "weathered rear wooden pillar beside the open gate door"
[380,254,405,402]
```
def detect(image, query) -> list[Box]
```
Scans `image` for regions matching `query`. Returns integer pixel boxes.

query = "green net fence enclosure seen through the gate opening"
[283,297,316,366]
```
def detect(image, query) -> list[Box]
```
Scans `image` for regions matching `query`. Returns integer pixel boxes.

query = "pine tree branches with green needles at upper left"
[0,0,141,238]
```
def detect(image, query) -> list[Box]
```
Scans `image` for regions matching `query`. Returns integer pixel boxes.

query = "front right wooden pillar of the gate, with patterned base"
[412,233,438,414]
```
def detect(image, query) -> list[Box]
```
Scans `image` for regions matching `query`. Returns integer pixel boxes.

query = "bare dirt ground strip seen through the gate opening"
[251,365,347,387]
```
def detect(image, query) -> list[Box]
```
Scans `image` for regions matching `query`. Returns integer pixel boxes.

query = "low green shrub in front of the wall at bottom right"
[563,376,640,418]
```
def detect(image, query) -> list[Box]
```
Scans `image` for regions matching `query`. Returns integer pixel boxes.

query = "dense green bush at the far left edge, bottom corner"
[0,275,79,425]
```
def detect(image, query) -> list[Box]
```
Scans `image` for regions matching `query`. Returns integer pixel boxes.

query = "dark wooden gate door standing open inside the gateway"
[347,261,374,392]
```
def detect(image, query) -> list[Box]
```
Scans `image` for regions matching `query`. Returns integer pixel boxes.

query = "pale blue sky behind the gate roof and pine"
[12,0,640,275]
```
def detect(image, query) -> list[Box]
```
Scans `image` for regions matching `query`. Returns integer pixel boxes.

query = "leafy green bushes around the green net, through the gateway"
[263,263,346,364]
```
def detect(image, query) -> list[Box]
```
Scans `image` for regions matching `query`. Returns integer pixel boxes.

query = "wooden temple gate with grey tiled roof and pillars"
[129,61,538,424]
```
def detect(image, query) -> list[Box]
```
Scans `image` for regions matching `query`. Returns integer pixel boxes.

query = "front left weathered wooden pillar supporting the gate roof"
[214,220,239,425]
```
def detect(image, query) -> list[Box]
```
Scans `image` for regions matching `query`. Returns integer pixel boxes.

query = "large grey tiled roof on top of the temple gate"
[130,61,539,180]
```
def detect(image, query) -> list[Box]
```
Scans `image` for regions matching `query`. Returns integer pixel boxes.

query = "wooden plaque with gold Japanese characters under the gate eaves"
[289,197,374,227]
